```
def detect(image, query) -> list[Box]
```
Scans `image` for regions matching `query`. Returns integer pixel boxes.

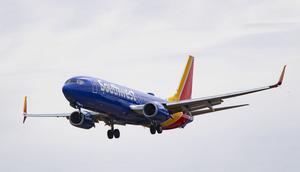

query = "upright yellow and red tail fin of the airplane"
[168,56,194,102]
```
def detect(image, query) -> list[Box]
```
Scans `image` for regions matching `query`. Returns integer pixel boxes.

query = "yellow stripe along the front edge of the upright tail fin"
[168,55,194,102]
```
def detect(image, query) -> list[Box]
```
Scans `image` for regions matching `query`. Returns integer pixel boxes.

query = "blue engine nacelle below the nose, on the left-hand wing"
[69,111,95,129]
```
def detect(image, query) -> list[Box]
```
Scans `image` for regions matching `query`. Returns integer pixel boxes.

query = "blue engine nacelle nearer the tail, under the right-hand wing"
[143,102,170,121]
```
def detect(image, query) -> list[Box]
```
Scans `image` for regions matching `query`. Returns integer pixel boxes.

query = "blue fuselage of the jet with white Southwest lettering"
[62,76,170,125]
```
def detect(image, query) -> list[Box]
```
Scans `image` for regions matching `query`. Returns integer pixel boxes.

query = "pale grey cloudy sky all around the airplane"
[0,0,300,172]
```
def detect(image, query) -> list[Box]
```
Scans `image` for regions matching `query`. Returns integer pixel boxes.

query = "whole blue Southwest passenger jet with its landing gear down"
[23,56,286,139]
